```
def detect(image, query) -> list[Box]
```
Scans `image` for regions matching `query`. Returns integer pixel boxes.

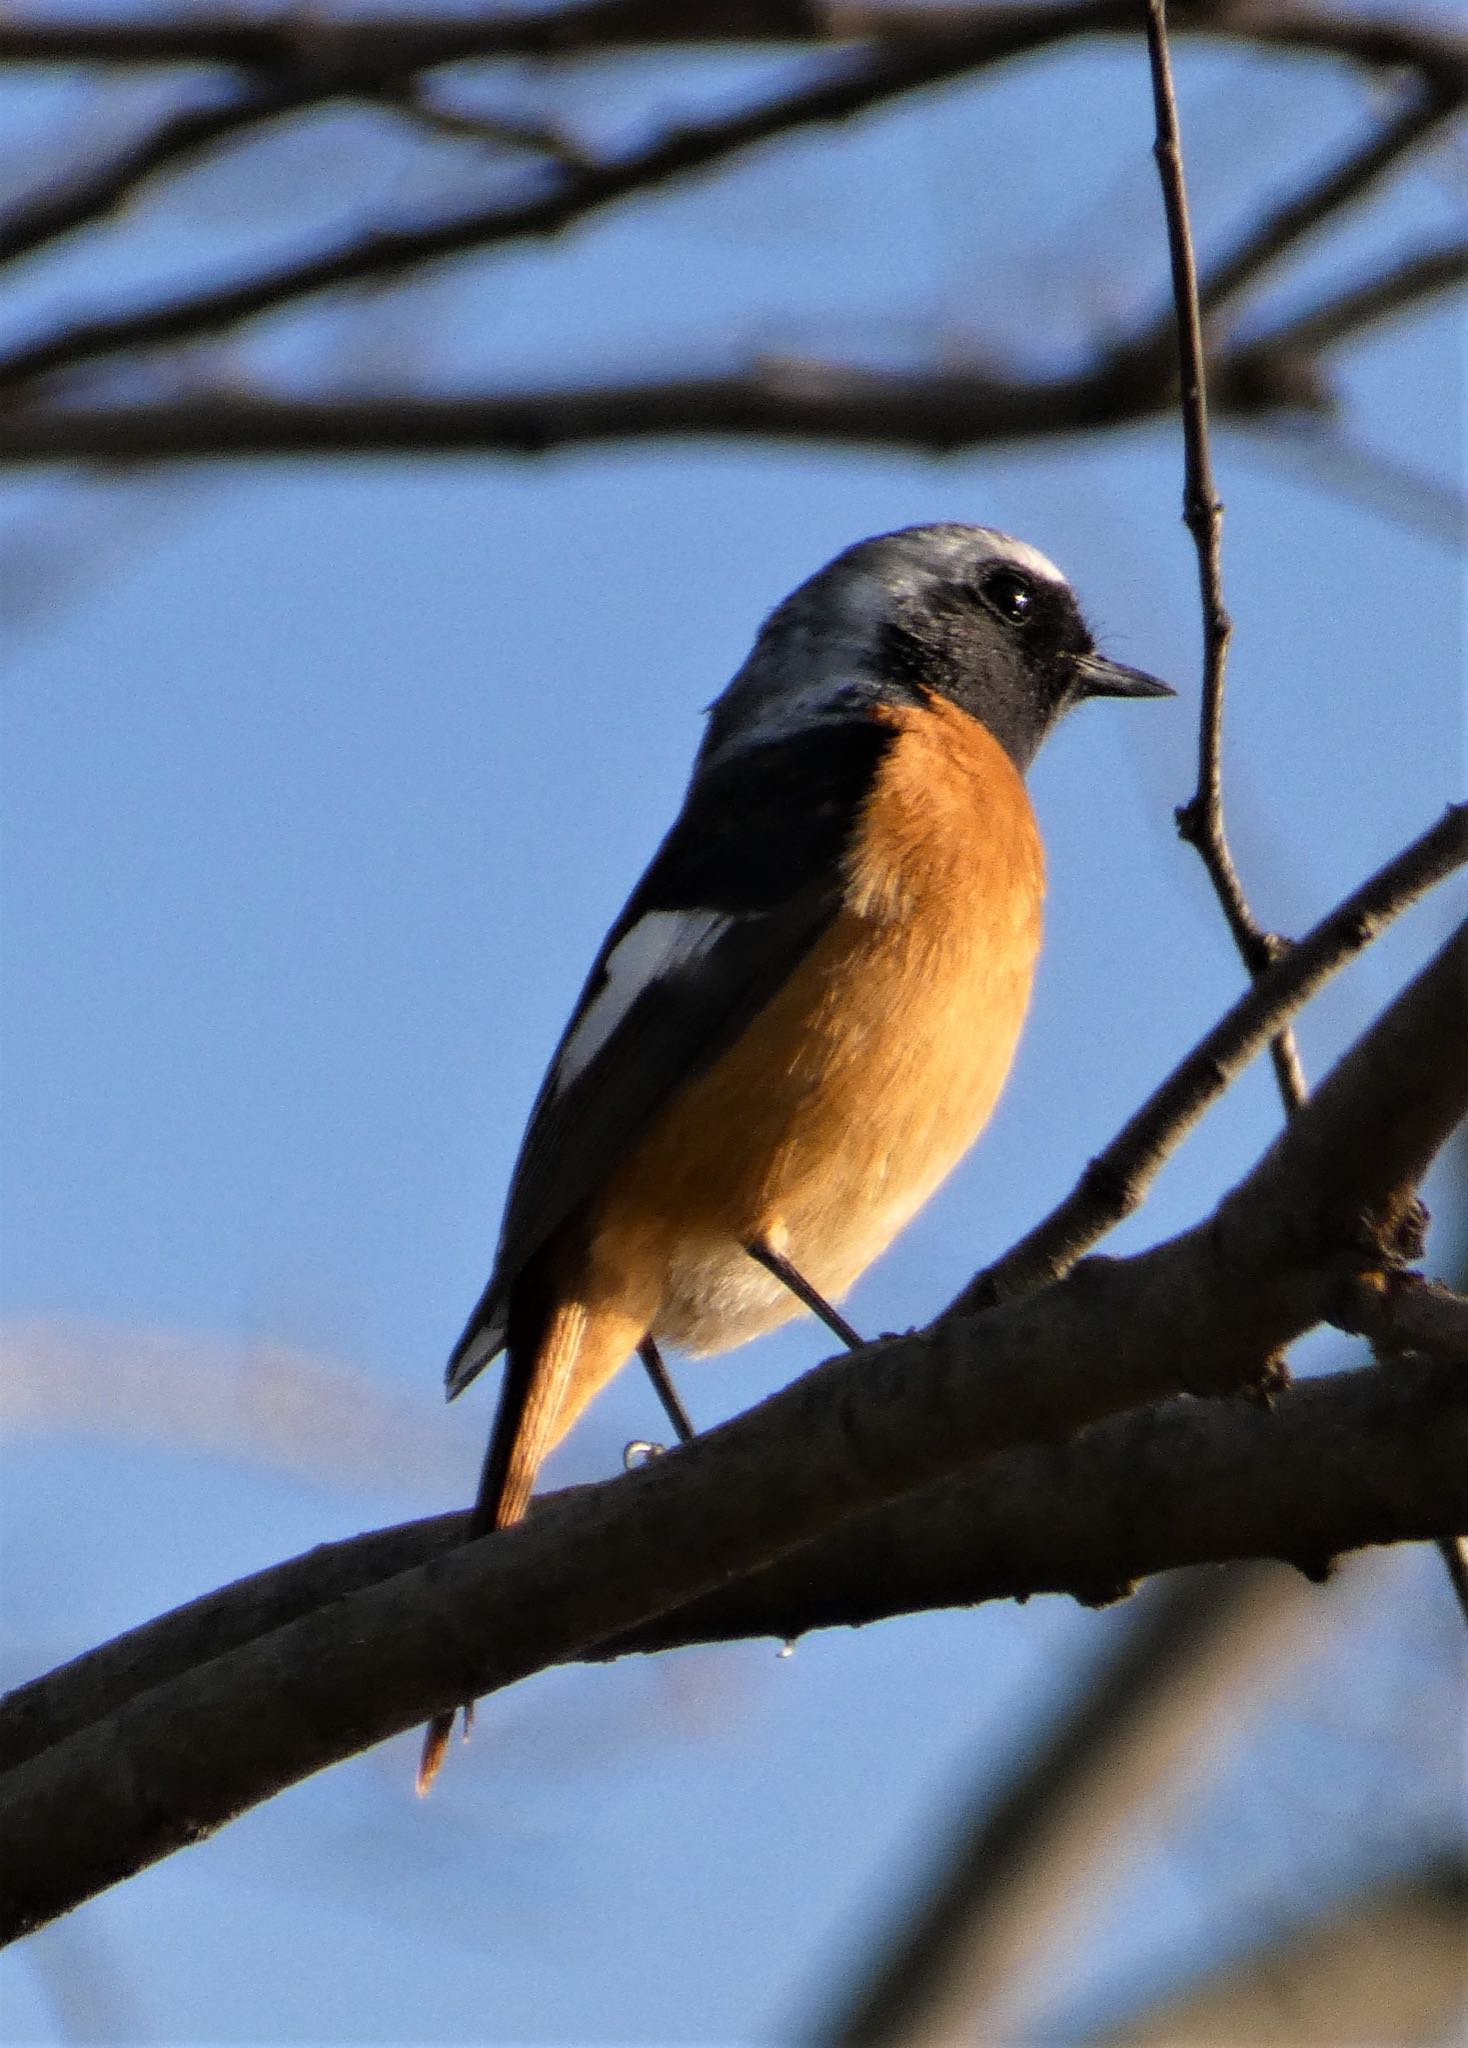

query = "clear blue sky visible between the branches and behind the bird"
[0,19,1462,2042]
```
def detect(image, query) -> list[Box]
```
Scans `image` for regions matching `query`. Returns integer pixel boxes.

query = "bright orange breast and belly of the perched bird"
[588,700,1044,1350]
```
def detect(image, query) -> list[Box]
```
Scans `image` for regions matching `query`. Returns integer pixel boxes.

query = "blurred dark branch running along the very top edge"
[0,0,1468,78]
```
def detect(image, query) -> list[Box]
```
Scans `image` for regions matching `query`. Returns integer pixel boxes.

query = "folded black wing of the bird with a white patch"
[446,719,893,1395]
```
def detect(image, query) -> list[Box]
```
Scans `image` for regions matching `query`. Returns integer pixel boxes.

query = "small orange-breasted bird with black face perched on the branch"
[418,522,1175,1792]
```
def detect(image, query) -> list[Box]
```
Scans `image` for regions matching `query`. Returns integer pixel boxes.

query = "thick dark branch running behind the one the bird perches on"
[0,1364,1468,1774]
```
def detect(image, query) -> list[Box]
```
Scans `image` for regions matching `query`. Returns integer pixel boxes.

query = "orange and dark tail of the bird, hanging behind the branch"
[418,1298,643,1796]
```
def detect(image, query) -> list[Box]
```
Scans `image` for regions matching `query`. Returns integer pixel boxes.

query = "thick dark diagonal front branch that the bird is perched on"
[0,924,1468,1937]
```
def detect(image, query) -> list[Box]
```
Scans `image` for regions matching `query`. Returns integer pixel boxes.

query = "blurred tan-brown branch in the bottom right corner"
[1095,1853,1468,2048]
